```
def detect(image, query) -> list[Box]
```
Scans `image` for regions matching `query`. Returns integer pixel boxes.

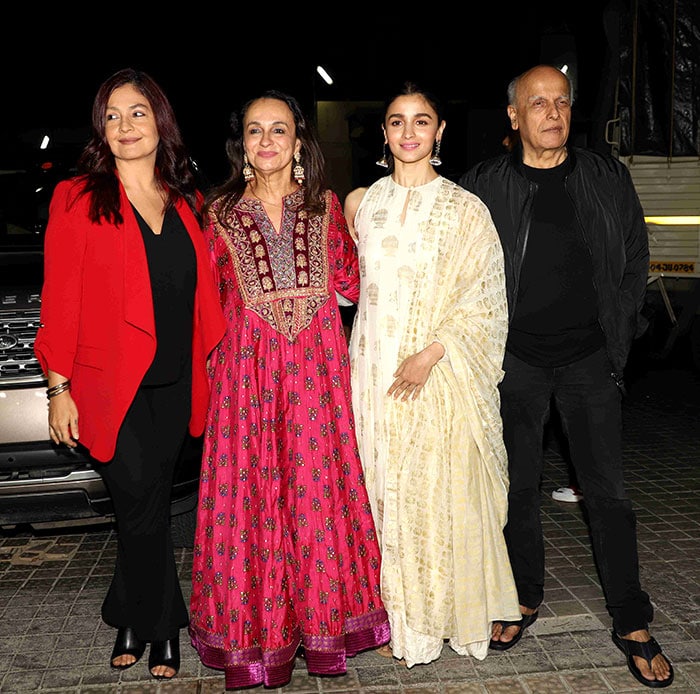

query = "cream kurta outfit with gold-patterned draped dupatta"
[350,176,520,667]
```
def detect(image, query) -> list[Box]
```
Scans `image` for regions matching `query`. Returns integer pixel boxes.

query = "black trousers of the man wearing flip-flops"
[500,350,653,634]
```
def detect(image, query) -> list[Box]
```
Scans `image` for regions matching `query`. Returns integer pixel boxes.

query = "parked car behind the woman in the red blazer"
[0,133,202,546]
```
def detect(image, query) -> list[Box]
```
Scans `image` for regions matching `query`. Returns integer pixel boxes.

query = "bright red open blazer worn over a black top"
[34,179,226,462]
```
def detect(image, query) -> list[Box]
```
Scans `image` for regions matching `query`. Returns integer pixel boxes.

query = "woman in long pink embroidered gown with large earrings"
[190,91,390,688]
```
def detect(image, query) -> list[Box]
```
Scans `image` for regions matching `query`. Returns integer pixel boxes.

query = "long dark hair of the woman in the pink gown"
[205,89,328,222]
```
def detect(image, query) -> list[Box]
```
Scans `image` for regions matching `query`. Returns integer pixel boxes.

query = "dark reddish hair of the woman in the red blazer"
[78,68,201,224]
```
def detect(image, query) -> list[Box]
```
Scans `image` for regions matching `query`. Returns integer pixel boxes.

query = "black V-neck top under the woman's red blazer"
[132,205,197,386]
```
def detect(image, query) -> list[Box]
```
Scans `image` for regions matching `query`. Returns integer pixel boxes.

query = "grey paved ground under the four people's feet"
[0,368,700,694]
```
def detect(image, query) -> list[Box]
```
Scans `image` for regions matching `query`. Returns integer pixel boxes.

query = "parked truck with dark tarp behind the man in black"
[597,0,700,369]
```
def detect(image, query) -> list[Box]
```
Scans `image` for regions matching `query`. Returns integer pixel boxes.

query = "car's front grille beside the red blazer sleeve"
[0,293,44,385]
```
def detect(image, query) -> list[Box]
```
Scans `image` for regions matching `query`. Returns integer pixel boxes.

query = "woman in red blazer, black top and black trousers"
[34,69,225,678]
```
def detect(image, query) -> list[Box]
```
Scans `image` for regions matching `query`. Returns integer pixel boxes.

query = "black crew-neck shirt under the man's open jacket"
[507,158,605,367]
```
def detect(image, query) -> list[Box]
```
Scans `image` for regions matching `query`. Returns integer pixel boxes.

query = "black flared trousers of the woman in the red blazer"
[96,379,191,641]
